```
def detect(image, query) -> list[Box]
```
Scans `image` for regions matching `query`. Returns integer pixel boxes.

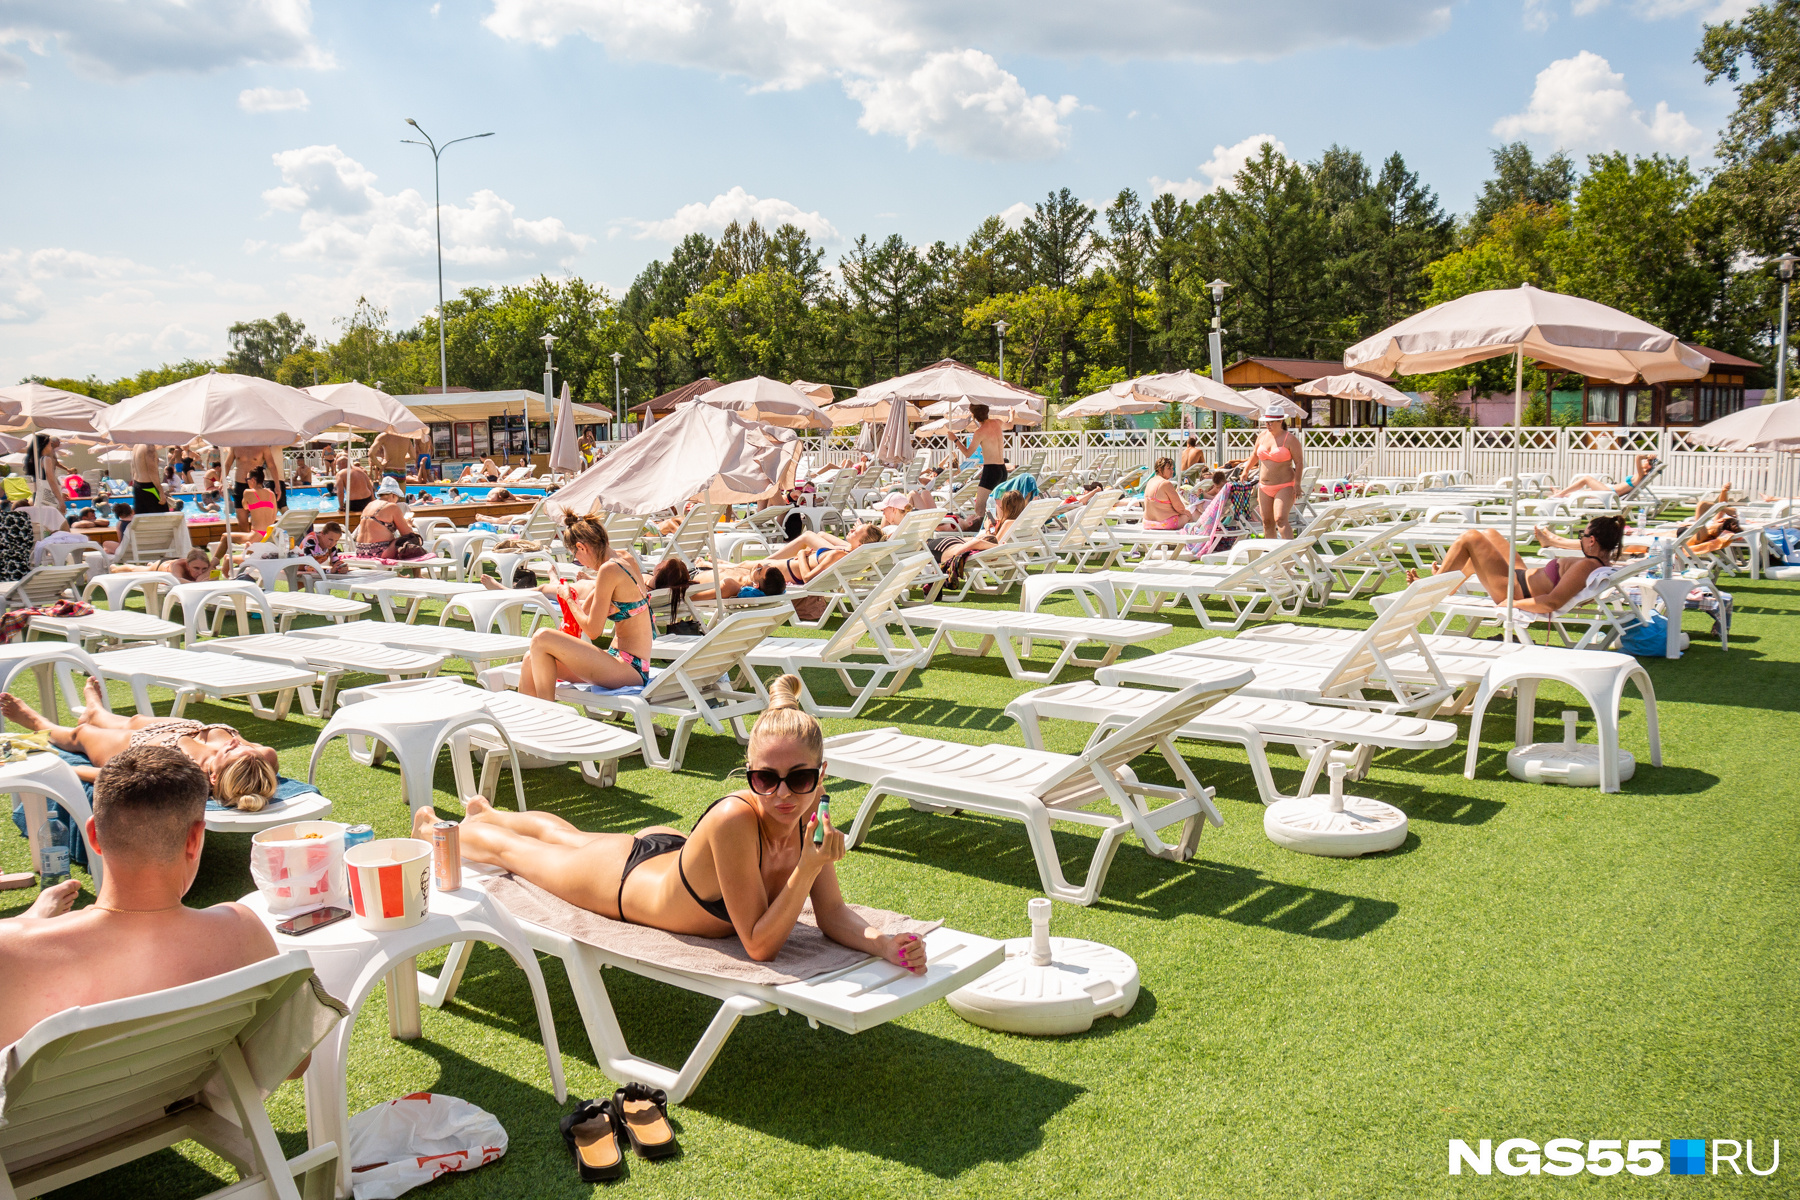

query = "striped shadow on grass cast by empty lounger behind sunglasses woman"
[857,801,1399,941]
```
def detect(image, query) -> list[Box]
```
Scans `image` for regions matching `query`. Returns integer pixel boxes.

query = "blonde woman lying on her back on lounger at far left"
[0,680,281,813]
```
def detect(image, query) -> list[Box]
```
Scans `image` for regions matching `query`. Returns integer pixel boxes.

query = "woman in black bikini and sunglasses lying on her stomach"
[414,675,925,975]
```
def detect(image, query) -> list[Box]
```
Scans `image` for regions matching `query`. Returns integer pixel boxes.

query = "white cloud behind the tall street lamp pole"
[263,146,592,275]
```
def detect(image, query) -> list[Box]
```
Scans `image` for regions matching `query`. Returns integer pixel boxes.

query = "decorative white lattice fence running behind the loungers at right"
[808,425,1796,495]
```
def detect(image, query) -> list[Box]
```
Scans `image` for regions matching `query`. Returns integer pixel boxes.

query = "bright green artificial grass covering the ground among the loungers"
[14,579,1800,1200]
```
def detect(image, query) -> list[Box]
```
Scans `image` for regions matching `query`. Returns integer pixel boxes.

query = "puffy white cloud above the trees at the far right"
[1494,50,1706,155]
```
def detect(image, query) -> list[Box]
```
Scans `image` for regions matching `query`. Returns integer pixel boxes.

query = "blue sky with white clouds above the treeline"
[0,0,1746,383]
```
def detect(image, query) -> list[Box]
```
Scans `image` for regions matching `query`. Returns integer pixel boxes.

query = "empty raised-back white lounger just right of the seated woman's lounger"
[743,554,931,718]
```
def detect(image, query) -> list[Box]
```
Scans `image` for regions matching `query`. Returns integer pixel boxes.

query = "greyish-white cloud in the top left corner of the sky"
[0,0,331,79]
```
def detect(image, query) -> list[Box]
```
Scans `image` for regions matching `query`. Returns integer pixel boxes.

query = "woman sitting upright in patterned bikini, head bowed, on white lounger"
[518,513,655,700]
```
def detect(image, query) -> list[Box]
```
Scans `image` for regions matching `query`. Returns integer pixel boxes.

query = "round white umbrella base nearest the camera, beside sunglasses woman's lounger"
[945,935,1138,1036]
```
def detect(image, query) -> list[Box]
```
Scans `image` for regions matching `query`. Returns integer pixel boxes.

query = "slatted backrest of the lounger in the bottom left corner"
[0,950,313,1169]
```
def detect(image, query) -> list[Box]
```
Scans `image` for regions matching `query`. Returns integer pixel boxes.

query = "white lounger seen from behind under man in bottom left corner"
[0,952,342,1200]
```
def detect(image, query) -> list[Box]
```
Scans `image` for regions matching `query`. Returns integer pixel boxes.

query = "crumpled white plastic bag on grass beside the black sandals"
[349,1092,506,1200]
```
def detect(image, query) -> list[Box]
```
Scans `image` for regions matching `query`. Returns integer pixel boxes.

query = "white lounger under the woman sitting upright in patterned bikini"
[481,604,792,770]
